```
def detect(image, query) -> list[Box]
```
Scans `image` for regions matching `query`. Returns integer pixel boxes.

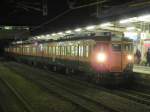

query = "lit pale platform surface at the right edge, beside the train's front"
[133,65,150,75]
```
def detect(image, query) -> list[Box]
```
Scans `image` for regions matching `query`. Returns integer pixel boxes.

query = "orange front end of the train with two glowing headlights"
[91,41,134,84]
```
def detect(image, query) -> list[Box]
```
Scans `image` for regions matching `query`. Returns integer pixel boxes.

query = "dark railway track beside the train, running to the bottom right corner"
[3,62,150,112]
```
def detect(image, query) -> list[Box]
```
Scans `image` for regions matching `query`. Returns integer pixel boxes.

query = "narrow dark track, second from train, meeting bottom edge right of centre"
[2,62,118,112]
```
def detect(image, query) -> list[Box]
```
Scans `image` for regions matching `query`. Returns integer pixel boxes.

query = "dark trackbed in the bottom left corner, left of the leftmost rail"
[0,74,34,112]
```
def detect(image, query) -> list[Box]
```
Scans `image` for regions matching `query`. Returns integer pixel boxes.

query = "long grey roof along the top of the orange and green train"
[12,31,132,45]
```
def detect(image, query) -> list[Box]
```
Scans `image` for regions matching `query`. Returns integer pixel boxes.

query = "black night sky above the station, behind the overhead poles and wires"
[0,0,134,32]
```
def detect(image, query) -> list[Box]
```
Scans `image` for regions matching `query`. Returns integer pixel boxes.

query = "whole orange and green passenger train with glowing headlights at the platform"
[5,32,134,84]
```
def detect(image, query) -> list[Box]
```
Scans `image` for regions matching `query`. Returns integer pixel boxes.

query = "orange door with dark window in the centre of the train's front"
[110,43,122,72]
